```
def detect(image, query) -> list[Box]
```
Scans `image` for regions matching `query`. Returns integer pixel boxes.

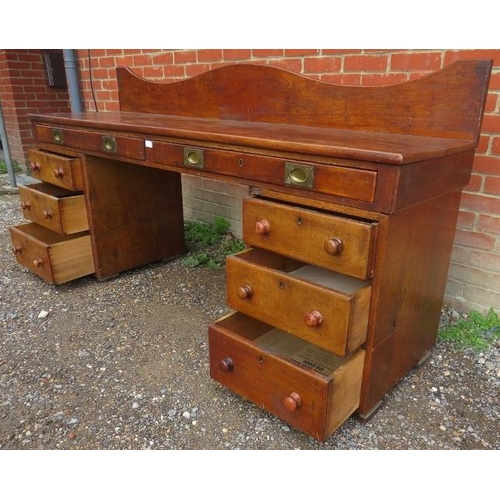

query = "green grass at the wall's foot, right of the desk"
[438,309,500,352]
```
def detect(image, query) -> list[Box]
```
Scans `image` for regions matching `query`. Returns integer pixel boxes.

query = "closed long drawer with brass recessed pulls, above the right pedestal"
[147,141,377,203]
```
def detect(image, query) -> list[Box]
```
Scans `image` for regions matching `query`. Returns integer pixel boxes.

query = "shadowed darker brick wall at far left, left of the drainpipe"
[0,49,69,166]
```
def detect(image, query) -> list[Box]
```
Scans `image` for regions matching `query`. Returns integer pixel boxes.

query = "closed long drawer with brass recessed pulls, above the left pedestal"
[35,124,145,160]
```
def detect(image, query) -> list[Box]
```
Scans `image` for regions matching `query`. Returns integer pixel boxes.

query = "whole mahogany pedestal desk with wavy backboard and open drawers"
[11,60,491,441]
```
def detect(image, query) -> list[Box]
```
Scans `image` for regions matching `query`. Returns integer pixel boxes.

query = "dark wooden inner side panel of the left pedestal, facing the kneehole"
[84,156,185,278]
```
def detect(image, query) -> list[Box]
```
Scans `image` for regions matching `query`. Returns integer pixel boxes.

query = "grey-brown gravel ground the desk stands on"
[0,188,500,450]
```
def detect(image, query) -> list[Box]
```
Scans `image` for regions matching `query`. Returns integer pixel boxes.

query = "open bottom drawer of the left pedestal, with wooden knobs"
[10,222,94,284]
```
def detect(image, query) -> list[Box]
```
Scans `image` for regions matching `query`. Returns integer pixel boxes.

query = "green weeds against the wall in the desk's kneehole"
[182,217,245,269]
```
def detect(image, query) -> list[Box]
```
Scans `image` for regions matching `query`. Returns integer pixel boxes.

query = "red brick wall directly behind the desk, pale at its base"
[71,49,500,311]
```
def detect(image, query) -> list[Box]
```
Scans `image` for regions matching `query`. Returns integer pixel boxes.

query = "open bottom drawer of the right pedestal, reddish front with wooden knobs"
[209,313,364,441]
